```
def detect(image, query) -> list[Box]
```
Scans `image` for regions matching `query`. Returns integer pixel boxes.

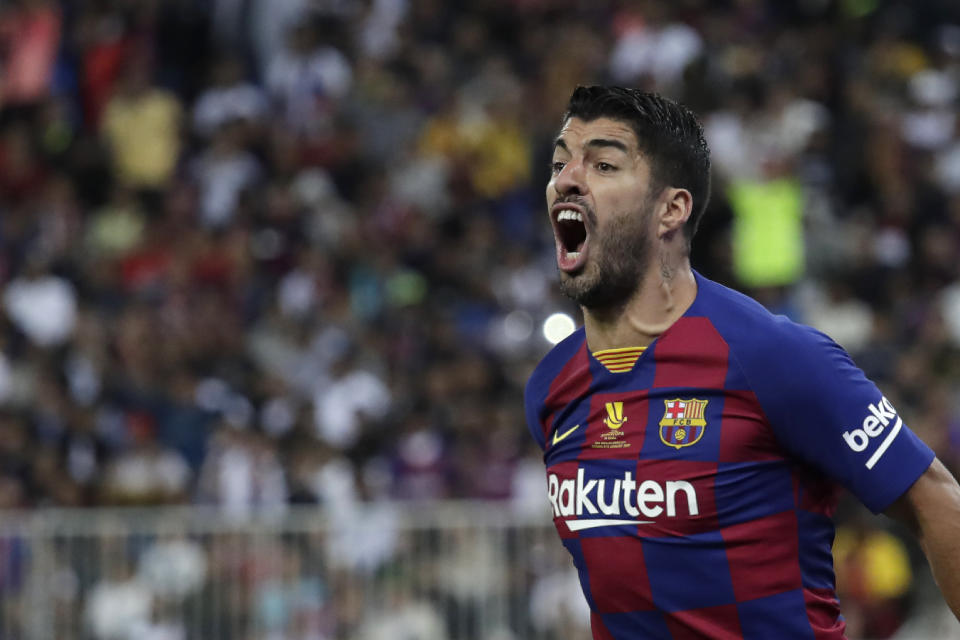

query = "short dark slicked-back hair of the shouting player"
[563,86,710,243]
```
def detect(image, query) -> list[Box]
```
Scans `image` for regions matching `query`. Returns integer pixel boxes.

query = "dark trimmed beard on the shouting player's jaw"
[560,206,651,311]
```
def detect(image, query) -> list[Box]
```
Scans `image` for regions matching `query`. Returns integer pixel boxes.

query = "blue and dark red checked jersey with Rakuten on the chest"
[525,274,933,640]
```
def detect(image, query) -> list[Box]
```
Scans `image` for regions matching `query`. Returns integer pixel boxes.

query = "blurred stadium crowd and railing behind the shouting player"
[0,0,960,640]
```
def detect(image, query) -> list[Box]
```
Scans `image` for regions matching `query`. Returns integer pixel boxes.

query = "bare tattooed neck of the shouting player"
[583,257,697,351]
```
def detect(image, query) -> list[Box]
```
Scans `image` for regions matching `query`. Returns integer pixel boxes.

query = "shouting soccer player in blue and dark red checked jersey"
[525,87,960,640]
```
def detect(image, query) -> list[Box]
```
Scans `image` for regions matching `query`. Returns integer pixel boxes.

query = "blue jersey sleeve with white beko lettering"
[738,318,934,513]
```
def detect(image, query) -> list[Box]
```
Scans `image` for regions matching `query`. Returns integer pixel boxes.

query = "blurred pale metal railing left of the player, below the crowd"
[0,503,590,640]
